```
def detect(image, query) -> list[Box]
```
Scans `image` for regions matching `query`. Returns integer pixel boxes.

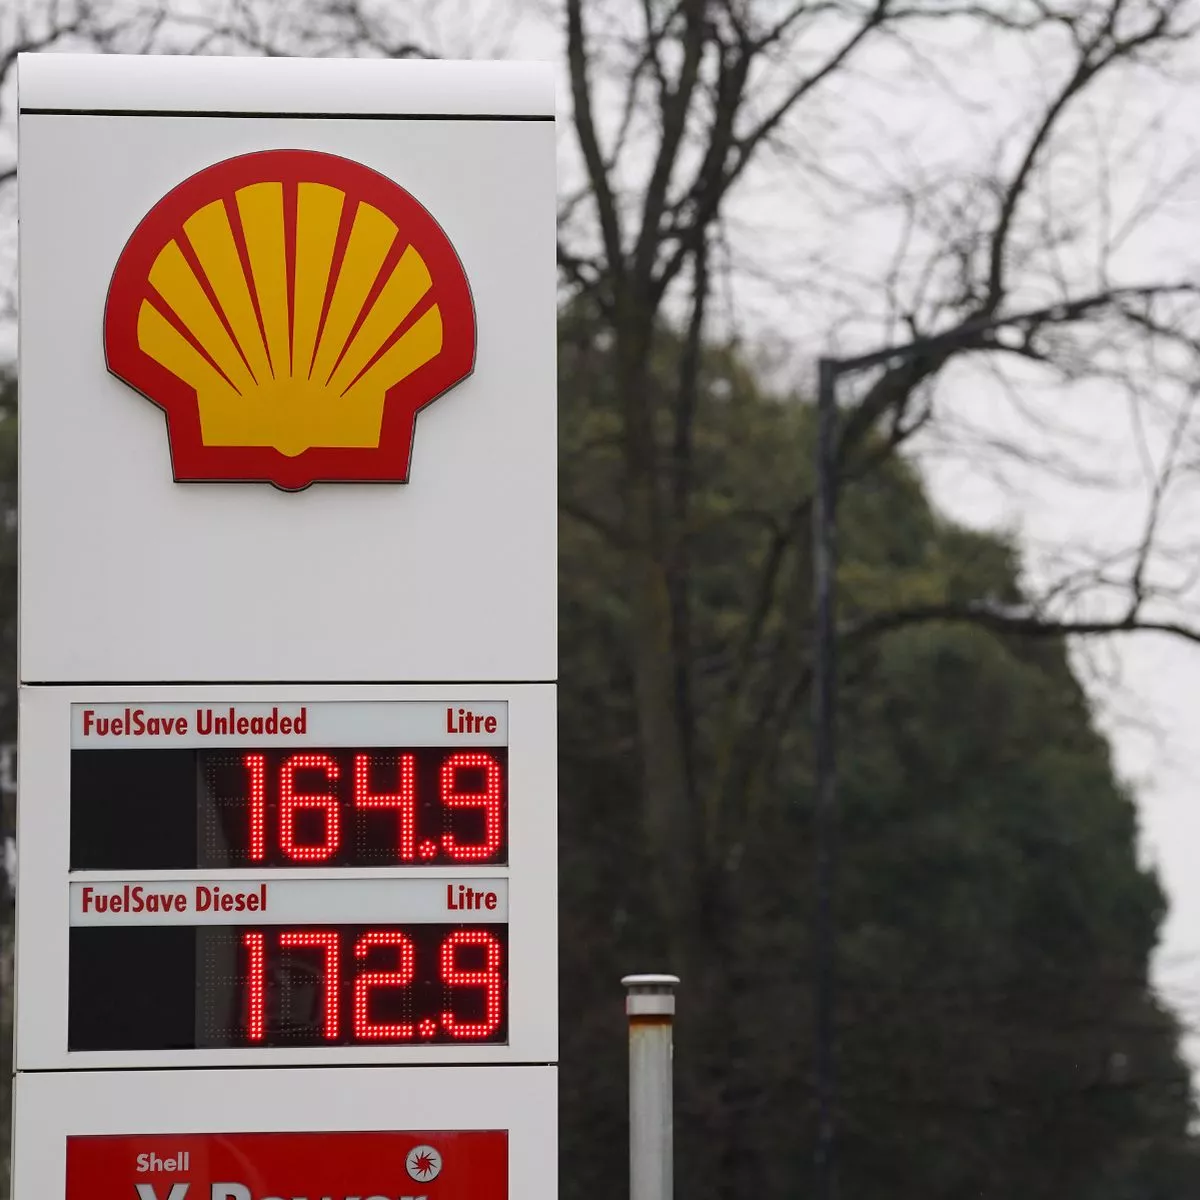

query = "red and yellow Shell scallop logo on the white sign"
[104,150,475,491]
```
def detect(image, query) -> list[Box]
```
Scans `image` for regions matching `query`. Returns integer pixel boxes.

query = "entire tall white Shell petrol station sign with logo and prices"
[13,55,557,1200]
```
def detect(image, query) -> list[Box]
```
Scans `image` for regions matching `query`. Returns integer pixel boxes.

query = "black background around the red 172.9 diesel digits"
[67,916,508,1051]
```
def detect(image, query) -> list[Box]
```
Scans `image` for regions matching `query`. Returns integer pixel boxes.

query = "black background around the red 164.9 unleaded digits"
[71,746,508,870]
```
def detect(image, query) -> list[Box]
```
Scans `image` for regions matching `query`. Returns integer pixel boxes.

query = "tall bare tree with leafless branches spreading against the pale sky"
[560,0,1200,971]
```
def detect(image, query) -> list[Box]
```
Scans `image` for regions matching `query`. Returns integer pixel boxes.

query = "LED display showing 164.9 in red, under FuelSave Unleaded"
[71,746,509,870]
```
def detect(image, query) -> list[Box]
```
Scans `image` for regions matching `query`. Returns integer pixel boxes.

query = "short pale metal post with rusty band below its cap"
[620,976,679,1200]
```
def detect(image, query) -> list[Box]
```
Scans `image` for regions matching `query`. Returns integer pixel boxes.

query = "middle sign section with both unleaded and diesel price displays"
[15,685,554,1064]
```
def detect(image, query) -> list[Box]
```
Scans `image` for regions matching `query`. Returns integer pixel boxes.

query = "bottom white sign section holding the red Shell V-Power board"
[13,1067,558,1200]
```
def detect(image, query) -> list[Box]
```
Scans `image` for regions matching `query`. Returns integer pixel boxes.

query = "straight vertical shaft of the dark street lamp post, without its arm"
[812,359,839,1200]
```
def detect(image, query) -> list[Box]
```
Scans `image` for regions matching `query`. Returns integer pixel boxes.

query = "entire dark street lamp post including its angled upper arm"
[812,294,1099,1200]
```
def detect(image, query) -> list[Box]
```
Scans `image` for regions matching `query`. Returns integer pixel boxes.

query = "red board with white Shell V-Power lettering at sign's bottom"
[66,1129,509,1200]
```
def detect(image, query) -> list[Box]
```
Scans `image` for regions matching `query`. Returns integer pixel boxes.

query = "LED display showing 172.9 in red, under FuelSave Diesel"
[67,924,508,1050]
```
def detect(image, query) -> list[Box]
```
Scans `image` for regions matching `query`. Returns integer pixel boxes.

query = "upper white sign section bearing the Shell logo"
[19,55,557,682]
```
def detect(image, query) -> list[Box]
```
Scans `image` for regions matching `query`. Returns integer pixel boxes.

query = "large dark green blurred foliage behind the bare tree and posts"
[559,310,1200,1200]
